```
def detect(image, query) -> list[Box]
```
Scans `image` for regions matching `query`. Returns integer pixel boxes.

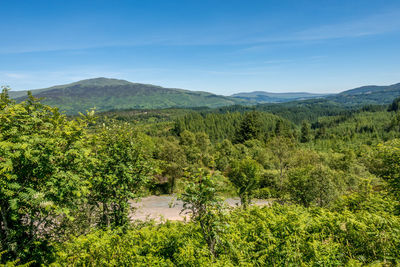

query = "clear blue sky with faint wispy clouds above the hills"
[0,0,400,95]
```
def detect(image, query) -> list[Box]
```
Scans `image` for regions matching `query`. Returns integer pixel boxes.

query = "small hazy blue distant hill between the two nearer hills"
[231,91,327,103]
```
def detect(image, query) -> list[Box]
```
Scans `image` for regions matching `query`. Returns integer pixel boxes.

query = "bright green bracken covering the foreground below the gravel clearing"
[53,205,400,266]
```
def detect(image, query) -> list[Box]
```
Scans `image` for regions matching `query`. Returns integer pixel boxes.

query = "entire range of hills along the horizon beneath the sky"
[10,78,400,114]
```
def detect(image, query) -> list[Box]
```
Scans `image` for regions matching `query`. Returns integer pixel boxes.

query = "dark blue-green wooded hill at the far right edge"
[326,83,400,106]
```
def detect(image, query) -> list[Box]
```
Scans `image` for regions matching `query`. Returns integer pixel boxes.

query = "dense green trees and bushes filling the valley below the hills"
[0,89,400,266]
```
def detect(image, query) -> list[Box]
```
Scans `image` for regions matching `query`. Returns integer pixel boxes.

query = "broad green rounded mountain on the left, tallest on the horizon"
[10,78,248,114]
